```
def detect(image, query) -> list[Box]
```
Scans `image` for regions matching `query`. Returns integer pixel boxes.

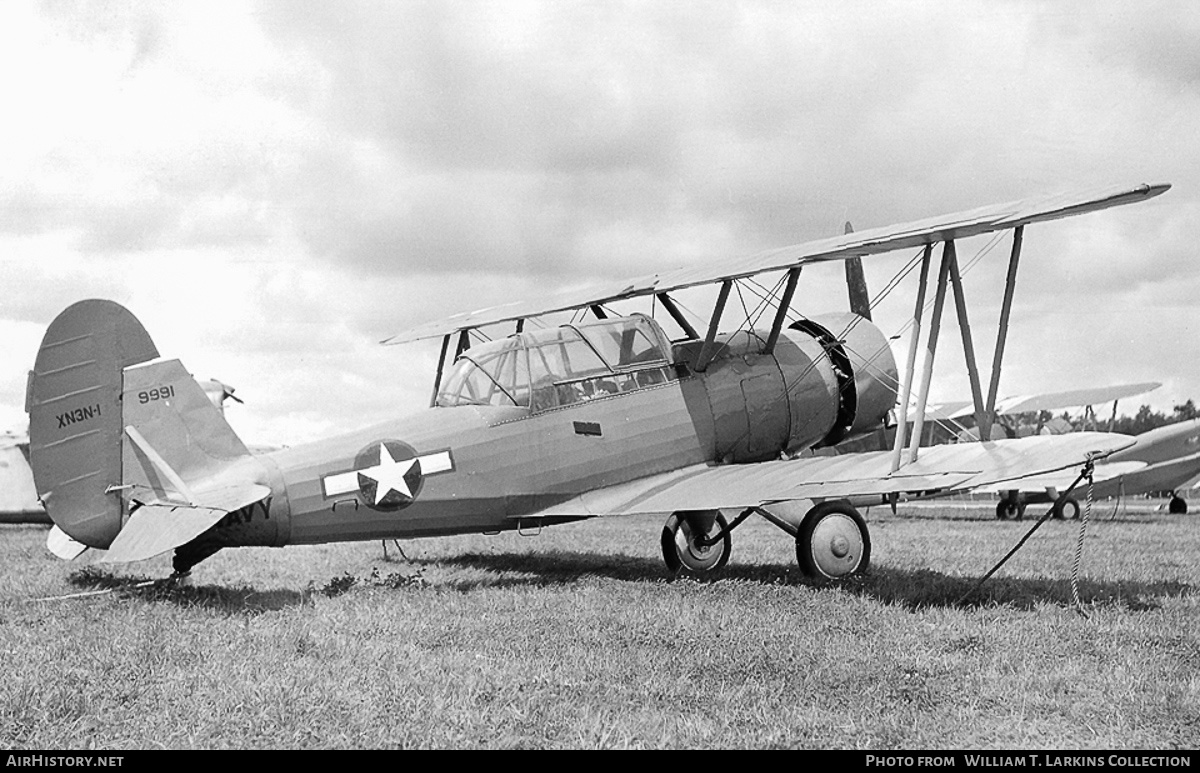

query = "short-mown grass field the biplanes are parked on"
[0,504,1200,750]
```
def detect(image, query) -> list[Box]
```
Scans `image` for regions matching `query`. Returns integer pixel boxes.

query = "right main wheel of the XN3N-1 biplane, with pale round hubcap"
[796,502,871,580]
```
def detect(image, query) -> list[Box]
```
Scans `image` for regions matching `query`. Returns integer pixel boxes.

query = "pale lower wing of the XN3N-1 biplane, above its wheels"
[533,432,1134,516]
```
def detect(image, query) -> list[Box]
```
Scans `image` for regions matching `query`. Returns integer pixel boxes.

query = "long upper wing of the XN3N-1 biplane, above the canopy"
[384,184,1171,343]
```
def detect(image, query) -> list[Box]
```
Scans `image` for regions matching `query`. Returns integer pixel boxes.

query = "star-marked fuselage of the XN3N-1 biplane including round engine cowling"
[198,314,895,547]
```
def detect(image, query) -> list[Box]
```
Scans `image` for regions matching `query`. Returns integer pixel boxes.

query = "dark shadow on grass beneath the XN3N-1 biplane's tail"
[64,567,307,615]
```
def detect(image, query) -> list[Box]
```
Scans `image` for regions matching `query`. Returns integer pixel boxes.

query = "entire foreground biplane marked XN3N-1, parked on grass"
[26,185,1170,580]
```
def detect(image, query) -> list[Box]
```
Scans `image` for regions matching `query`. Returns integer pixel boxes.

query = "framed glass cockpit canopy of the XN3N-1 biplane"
[437,314,678,411]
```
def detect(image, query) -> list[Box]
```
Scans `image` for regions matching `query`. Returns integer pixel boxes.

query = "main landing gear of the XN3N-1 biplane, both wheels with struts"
[662,501,871,581]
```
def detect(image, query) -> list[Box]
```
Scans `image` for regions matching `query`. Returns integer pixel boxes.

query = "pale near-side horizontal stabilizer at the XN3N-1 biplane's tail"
[101,484,271,563]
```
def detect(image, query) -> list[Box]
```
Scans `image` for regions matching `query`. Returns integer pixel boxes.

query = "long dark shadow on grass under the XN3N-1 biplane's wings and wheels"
[413,551,1195,611]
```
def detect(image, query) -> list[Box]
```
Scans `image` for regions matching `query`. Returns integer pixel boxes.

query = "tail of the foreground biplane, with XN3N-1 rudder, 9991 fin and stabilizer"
[26,300,270,561]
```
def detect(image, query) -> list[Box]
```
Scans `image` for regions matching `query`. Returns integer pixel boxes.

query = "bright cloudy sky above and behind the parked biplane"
[0,0,1200,443]
